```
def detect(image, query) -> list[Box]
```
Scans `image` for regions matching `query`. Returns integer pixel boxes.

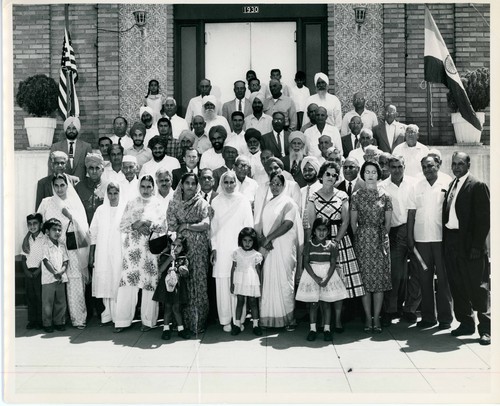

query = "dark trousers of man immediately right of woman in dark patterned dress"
[384,224,408,313]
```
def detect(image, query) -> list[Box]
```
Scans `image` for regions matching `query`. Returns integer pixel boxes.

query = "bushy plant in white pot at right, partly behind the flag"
[446,68,490,145]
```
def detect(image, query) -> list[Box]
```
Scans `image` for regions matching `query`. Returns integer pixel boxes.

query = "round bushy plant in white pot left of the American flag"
[16,75,58,149]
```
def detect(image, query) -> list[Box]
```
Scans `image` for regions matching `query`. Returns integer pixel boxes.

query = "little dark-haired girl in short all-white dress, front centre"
[231,227,263,336]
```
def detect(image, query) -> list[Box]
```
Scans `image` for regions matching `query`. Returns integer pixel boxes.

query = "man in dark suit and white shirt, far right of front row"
[443,152,491,345]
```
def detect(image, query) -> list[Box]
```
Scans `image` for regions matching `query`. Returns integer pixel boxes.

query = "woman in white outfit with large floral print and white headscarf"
[115,175,165,333]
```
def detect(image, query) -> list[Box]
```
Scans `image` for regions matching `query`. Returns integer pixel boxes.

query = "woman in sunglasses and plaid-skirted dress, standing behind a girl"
[304,161,365,333]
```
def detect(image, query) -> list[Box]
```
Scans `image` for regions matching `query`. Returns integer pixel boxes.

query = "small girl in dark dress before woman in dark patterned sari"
[153,236,191,340]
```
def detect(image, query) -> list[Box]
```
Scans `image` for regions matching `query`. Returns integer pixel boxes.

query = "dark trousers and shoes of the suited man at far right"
[444,228,491,334]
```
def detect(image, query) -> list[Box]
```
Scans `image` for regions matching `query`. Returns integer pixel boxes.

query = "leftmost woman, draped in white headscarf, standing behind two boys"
[38,175,90,329]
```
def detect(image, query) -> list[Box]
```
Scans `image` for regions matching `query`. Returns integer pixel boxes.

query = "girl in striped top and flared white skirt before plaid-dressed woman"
[295,217,348,341]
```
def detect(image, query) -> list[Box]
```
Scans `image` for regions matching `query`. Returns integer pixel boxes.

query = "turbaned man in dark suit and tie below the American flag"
[48,117,92,180]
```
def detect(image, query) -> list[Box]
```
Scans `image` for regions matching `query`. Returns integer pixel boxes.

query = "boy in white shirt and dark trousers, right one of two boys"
[42,218,69,333]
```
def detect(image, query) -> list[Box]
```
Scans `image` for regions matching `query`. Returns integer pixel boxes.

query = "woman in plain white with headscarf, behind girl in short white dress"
[210,171,253,332]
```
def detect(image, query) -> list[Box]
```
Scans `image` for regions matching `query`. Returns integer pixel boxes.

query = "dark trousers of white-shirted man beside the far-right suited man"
[415,241,453,323]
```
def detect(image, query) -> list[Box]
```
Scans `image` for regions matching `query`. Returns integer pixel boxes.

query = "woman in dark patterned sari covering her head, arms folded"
[167,172,210,334]
